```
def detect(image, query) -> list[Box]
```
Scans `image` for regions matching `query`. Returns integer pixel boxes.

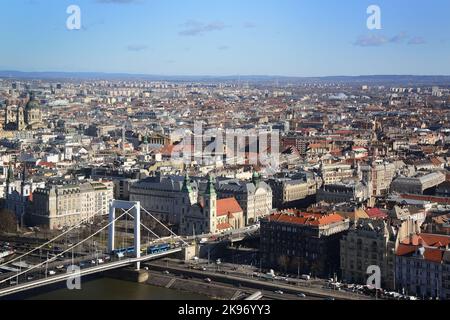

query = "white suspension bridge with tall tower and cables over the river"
[0,200,189,297]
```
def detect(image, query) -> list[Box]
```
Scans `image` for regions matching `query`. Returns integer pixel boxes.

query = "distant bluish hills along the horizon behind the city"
[0,70,450,86]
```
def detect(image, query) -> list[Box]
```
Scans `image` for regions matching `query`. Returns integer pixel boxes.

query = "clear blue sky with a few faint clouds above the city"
[0,0,450,76]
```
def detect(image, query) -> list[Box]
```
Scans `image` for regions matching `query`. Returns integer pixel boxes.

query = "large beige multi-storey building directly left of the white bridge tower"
[29,182,113,230]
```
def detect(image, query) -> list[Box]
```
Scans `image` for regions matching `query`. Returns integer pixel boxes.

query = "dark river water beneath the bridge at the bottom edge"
[16,278,208,300]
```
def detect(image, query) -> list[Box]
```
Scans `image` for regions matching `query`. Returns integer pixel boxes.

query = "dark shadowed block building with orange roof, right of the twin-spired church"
[260,210,350,277]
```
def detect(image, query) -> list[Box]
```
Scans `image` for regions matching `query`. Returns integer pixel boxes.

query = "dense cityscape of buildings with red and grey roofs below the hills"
[0,78,450,299]
